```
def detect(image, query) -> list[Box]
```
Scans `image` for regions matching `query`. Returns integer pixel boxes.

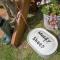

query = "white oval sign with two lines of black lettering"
[27,28,58,55]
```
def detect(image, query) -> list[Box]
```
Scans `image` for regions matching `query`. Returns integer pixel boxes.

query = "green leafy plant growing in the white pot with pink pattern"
[41,4,60,15]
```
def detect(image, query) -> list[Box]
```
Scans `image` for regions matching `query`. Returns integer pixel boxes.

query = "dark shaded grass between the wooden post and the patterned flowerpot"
[27,7,43,28]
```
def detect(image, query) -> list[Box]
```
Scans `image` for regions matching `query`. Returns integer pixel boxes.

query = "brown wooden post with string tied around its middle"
[11,0,30,47]
